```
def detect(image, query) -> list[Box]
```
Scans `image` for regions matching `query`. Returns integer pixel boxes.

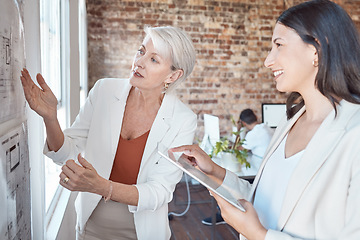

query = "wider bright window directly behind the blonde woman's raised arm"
[40,0,67,212]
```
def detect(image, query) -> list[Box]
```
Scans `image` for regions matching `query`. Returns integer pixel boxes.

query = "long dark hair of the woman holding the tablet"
[277,0,360,119]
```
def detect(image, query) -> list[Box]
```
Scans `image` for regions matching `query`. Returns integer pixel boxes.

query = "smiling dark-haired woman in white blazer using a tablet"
[173,0,360,240]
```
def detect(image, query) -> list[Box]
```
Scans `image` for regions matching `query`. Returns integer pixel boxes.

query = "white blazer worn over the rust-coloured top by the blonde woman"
[44,79,197,240]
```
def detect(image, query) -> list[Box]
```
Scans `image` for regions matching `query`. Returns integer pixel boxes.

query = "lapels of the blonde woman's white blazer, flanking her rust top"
[110,81,176,176]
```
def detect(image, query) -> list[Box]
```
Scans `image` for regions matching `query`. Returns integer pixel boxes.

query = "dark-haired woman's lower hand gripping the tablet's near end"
[211,192,267,239]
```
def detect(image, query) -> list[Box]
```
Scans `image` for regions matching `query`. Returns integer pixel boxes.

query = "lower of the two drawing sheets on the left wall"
[0,123,31,239]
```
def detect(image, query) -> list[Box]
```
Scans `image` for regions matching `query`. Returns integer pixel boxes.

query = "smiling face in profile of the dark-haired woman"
[264,23,318,94]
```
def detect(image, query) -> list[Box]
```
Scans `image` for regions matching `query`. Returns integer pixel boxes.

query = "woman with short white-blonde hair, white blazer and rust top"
[21,26,197,240]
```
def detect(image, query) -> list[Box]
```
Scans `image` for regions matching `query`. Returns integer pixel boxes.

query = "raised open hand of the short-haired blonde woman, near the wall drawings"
[20,68,57,121]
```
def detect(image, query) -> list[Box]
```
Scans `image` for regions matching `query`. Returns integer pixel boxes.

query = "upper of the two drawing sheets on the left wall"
[0,0,25,124]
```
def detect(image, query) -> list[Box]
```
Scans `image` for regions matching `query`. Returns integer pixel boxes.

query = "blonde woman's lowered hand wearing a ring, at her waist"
[59,154,109,196]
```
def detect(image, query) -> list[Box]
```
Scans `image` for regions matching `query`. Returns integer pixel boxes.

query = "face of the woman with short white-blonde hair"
[130,37,176,93]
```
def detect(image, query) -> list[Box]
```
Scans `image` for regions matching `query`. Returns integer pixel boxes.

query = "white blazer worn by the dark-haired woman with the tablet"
[219,100,360,240]
